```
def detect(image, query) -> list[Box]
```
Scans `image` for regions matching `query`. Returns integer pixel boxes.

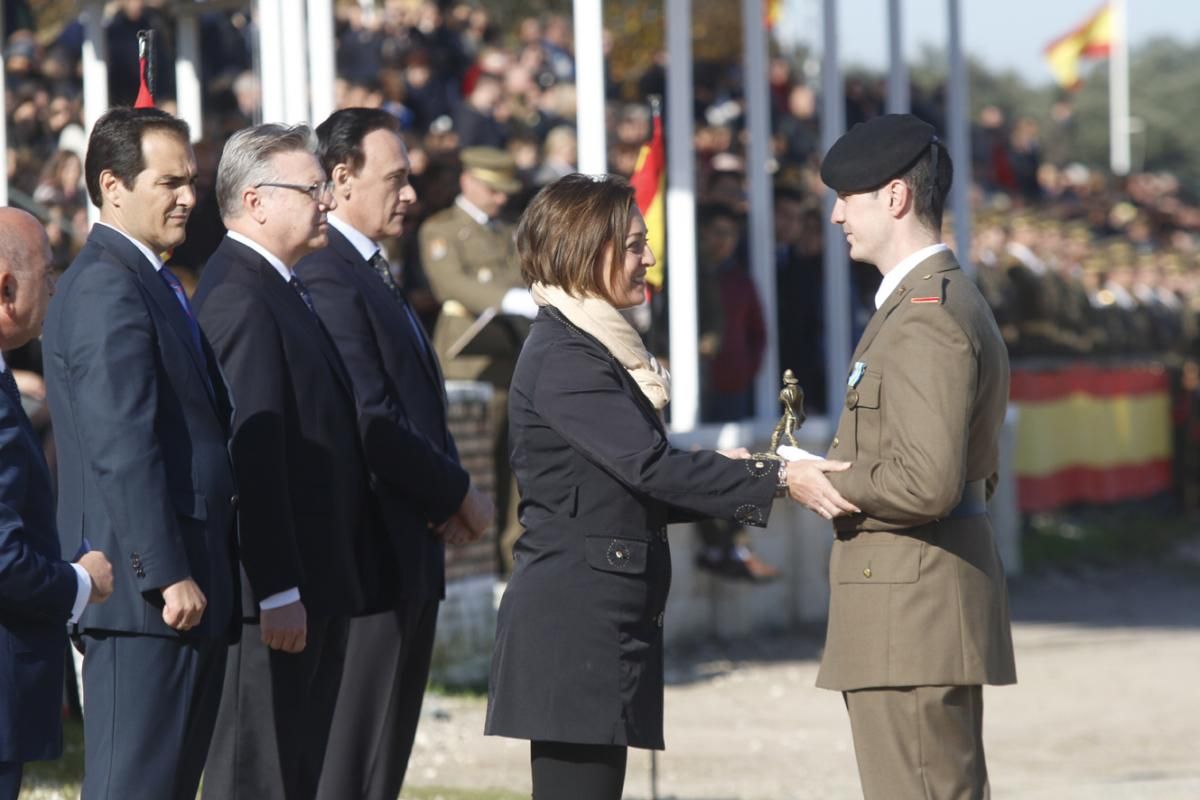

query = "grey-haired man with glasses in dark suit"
[196,125,395,800]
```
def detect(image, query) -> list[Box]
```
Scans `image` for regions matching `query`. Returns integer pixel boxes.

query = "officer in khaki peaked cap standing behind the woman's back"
[418,148,538,572]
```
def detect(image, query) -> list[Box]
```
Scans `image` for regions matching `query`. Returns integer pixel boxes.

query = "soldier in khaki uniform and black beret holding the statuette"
[787,114,1016,800]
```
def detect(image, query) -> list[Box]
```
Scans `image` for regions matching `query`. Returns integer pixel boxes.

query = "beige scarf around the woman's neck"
[530,283,671,411]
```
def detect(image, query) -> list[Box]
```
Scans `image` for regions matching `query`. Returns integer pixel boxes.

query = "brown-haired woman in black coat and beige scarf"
[485,175,780,800]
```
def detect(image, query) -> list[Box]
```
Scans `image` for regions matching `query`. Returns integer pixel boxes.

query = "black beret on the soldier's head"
[821,114,938,194]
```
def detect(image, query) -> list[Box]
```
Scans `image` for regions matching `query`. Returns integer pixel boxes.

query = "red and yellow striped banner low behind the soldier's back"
[1012,365,1171,512]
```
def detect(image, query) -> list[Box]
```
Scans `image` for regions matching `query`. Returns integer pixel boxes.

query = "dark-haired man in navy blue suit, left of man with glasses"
[44,109,238,800]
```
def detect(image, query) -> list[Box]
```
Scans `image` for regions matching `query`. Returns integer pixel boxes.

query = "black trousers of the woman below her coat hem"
[529,741,628,800]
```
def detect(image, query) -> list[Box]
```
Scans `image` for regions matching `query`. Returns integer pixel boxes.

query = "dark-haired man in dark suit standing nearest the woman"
[296,108,493,800]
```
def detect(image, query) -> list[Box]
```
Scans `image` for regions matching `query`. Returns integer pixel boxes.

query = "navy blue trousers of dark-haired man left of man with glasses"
[82,632,228,800]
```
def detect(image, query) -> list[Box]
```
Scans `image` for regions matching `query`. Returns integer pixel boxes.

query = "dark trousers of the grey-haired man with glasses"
[204,616,349,800]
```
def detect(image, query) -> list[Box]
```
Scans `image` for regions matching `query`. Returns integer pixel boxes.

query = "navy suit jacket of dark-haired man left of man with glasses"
[43,224,241,638]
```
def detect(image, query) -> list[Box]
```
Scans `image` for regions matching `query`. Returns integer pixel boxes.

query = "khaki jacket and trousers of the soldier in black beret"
[817,252,1016,798]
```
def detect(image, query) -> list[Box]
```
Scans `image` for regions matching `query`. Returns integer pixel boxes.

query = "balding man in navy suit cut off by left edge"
[0,209,113,800]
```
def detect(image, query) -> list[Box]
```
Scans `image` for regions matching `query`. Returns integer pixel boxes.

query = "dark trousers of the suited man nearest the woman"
[317,600,439,800]
